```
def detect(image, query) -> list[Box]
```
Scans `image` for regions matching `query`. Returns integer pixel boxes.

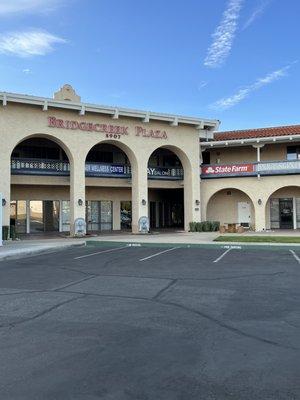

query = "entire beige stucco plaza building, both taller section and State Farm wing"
[0,85,300,235]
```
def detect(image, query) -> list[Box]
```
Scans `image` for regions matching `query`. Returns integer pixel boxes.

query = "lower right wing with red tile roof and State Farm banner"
[201,125,300,231]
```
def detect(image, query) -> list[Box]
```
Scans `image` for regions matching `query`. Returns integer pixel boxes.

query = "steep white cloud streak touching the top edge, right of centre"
[204,0,243,68]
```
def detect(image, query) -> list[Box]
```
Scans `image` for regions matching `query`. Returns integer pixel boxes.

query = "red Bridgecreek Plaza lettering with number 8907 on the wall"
[48,117,168,139]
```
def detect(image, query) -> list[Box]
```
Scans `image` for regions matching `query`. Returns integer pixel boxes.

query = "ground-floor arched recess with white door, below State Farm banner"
[206,188,255,229]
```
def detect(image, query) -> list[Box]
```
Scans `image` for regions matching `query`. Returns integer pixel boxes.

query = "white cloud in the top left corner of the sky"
[0,0,60,16]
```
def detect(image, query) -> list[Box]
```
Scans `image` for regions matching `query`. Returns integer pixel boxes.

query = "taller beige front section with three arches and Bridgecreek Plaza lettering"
[0,85,218,235]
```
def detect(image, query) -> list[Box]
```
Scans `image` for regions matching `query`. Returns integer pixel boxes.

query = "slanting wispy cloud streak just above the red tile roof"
[210,61,297,110]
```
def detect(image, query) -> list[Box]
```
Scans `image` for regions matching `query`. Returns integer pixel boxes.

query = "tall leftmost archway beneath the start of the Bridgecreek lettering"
[10,135,70,235]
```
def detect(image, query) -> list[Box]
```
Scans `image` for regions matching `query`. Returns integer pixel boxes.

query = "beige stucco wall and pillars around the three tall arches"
[0,103,201,233]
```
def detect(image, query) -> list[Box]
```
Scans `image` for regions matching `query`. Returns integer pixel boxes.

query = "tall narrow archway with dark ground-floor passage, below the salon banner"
[147,147,184,230]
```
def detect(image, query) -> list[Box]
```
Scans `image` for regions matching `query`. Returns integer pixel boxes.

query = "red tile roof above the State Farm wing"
[214,125,300,141]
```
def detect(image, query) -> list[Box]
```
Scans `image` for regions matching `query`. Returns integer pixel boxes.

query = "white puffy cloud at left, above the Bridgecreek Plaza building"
[0,30,66,57]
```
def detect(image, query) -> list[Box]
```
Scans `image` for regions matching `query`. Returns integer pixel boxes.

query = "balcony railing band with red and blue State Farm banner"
[201,160,300,178]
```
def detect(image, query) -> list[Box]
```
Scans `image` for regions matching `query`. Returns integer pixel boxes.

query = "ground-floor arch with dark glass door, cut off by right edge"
[266,186,300,229]
